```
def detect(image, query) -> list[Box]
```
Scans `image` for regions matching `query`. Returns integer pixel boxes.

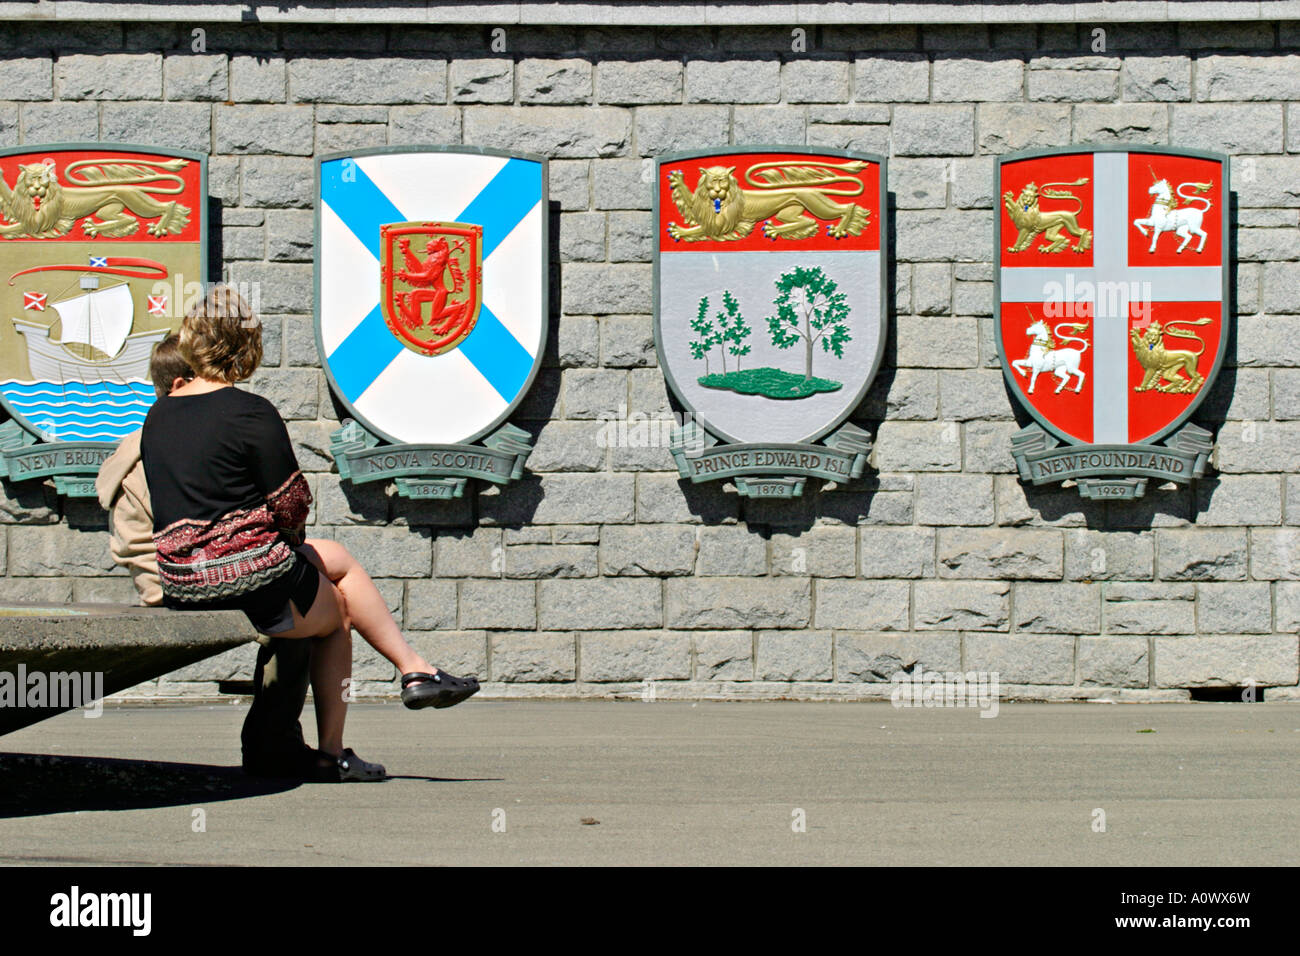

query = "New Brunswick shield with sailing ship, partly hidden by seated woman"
[0,143,207,497]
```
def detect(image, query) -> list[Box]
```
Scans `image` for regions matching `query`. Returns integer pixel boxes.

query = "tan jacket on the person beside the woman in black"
[95,432,163,605]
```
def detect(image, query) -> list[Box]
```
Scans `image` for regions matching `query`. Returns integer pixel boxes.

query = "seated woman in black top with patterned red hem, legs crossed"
[140,286,478,780]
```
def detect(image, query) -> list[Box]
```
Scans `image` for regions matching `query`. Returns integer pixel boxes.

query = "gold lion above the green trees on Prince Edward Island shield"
[668,160,871,242]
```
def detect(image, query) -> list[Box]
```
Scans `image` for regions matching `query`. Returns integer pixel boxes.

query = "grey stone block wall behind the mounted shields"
[0,13,1300,698]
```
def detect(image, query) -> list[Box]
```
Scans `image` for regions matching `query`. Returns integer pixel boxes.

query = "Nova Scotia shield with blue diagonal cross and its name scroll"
[316,147,547,498]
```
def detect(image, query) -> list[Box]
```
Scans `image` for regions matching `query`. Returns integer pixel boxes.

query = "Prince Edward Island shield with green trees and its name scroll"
[655,147,887,497]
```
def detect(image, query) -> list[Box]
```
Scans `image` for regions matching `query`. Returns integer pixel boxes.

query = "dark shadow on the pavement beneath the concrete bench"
[0,753,302,818]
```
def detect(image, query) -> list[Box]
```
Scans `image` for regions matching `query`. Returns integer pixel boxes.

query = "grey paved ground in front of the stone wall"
[0,701,1300,865]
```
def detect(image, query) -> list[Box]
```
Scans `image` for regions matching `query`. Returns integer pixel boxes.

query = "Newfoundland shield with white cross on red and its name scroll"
[995,147,1231,498]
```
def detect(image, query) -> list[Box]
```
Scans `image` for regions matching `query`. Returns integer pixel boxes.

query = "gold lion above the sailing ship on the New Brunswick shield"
[0,159,190,239]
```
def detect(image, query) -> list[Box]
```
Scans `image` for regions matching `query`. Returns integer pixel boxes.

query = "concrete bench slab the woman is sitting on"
[0,602,257,735]
